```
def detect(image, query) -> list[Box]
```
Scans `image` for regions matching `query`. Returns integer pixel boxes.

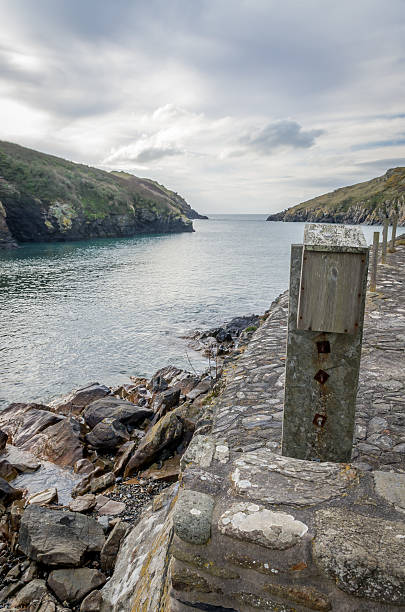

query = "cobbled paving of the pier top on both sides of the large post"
[205,237,405,472]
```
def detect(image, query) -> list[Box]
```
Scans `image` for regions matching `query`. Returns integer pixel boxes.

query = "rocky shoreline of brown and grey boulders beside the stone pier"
[0,315,266,612]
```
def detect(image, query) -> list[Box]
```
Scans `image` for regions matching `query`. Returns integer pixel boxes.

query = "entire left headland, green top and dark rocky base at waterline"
[0,141,204,247]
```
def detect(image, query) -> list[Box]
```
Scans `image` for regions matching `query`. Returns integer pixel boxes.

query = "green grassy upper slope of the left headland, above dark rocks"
[0,141,193,220]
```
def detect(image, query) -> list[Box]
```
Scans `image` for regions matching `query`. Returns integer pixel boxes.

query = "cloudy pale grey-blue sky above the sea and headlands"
[0,0,405,214]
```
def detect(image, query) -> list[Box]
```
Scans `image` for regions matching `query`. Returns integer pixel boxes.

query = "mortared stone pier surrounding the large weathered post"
[103,240,405,612]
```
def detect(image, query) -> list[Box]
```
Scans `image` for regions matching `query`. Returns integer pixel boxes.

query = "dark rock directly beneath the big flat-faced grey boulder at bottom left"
[48,567,106,604]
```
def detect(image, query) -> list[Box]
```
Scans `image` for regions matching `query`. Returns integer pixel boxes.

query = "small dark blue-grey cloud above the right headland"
[240,119,324,155]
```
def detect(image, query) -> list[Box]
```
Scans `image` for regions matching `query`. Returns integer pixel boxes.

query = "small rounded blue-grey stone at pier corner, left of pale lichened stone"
[173,489,214,544]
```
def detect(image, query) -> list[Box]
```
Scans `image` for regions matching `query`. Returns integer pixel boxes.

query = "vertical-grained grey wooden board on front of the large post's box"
[297,246,367,334]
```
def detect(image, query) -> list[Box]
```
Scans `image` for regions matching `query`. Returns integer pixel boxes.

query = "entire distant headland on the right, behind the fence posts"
[267,168,405,225]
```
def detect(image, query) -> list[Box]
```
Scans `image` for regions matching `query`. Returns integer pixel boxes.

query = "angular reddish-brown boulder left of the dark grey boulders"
[20,415,83,467]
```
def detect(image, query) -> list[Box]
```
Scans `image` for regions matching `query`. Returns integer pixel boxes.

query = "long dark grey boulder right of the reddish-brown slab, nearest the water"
[83,397,152,428]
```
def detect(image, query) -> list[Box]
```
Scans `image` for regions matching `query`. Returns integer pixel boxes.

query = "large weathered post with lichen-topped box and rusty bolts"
[282,224,368,462]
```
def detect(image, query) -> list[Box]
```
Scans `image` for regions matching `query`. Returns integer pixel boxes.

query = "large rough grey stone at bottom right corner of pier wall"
[313,508,405,605]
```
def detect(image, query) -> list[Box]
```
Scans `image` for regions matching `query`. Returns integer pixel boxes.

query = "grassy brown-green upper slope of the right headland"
[268,168,405,220]
